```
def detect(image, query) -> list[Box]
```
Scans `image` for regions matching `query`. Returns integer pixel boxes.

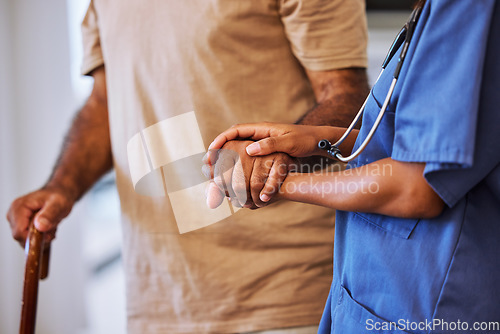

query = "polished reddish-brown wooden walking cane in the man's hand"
[19,222,50,334]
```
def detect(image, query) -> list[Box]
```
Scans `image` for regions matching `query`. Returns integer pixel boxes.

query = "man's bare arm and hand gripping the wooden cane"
[7,67,113,247]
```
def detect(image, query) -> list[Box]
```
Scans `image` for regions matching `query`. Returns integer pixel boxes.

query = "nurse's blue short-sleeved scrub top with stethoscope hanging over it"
[319,0,500,334]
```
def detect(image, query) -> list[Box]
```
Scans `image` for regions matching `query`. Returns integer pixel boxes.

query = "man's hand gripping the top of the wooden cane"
[7,189,74,247]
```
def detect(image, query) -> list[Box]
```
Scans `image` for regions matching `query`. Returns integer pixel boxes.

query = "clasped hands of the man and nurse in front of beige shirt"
[203,123,334,209]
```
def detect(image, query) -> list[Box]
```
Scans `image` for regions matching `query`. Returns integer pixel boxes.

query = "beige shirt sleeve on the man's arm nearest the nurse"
[280,0,368,71]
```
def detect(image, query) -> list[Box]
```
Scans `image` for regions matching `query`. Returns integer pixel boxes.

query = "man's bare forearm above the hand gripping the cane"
[45,92,112,201]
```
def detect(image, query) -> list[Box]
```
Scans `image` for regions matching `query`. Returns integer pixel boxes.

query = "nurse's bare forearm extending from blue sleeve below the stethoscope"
[279,158,443,218]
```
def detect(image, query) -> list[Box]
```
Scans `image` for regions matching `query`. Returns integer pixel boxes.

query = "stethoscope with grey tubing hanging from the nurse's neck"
[318,2,422,162]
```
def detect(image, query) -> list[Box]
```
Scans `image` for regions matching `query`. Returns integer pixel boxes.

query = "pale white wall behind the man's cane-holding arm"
[0,0,84,334]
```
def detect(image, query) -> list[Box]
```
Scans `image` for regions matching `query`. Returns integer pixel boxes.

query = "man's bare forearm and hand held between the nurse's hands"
[205,68,369,208]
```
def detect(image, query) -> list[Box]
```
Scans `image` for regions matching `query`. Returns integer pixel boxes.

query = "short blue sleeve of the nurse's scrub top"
[392,0,500,207]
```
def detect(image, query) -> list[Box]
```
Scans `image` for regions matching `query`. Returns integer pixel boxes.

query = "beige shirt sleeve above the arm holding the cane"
[81,0,104,75]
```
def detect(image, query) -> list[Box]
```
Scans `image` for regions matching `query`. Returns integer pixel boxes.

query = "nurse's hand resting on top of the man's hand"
[209,123,341,157]
